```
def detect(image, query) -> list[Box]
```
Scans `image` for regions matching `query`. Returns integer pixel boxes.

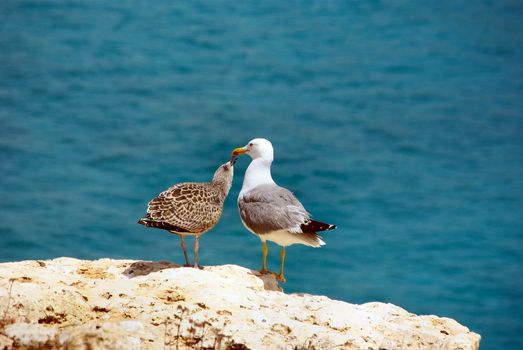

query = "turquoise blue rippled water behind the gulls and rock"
[0,0,523,349]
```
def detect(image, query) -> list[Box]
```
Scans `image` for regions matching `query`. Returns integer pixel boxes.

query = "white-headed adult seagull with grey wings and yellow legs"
[232,138,336,282]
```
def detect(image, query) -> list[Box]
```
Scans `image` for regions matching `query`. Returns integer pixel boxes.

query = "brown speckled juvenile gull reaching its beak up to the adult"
[138,157,236,267]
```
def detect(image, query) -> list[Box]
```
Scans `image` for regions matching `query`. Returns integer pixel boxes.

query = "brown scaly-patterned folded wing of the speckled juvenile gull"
[147,183,223,233]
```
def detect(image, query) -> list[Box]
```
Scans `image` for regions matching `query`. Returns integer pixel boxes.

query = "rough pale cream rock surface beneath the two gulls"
[0,258,480,350]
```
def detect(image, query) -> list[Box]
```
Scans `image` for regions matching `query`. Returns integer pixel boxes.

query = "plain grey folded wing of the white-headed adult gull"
[238,185,309,234]
